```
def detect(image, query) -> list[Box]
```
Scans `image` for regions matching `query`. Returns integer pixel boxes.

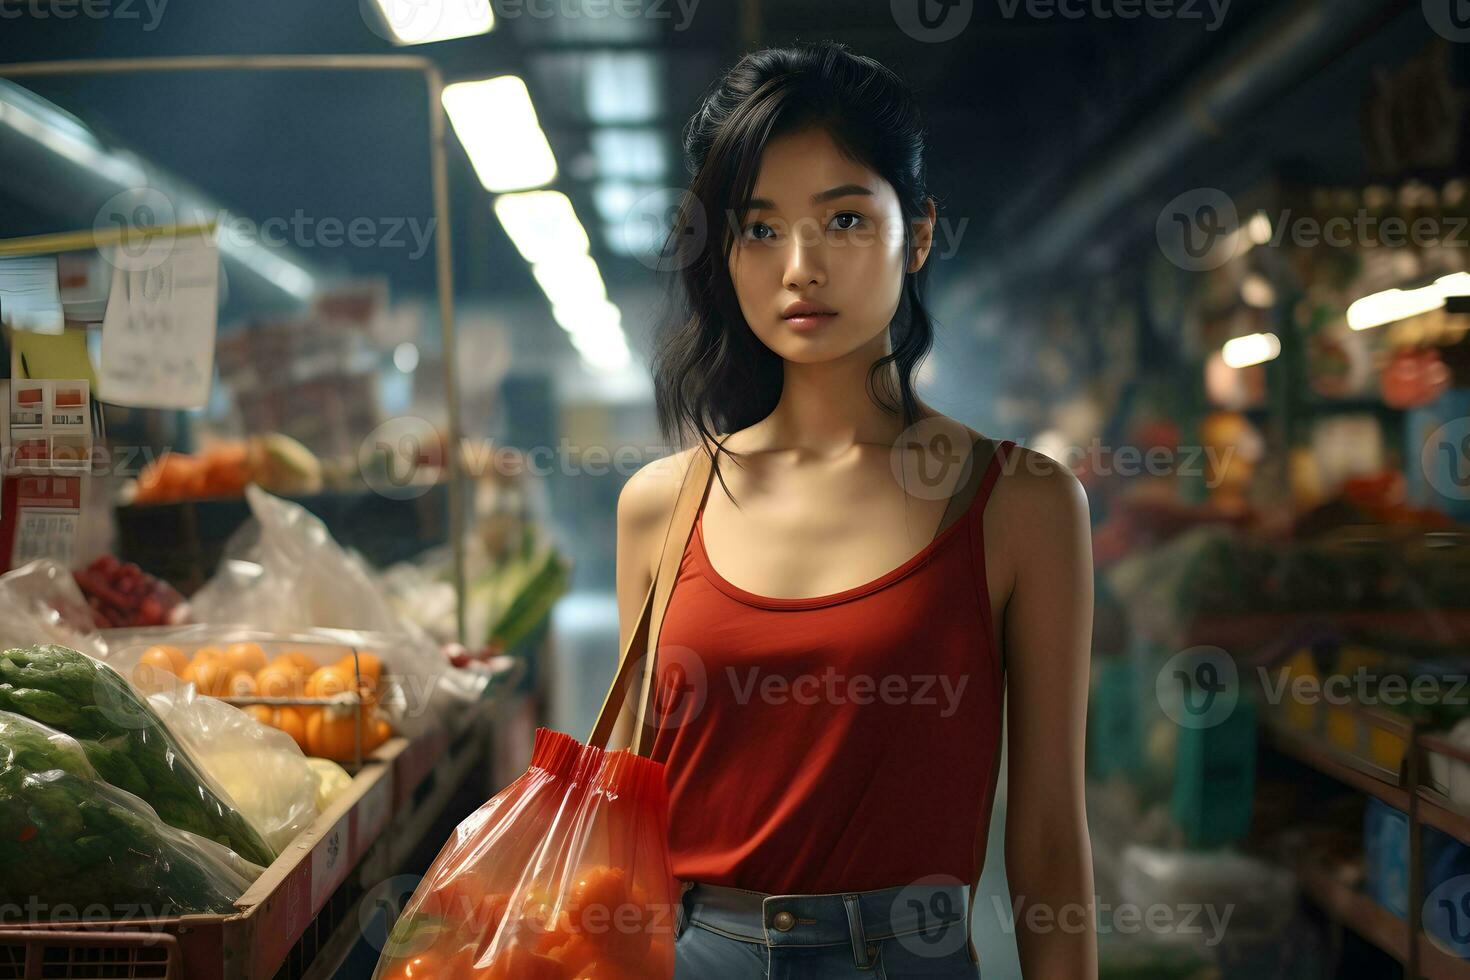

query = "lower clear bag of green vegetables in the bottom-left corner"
[0,711,263,926]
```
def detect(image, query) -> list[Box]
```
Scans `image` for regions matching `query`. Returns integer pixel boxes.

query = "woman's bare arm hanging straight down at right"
[1001,450,1098,980]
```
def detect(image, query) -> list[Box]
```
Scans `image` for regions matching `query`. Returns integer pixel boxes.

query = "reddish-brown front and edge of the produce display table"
[0,701,519,980]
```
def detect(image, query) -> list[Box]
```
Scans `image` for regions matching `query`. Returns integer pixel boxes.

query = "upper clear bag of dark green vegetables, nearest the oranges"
[0,645,275,867]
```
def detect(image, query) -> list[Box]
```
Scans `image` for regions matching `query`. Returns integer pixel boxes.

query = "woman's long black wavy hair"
[653,41,933,492]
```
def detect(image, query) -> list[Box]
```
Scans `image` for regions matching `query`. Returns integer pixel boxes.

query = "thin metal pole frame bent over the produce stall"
[0,54,466,642]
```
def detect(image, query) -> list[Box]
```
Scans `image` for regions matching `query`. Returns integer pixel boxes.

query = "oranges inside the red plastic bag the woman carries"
[379,864,673,980]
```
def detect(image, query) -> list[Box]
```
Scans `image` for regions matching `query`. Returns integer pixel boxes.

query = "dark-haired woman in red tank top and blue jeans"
[614,43,1097,980]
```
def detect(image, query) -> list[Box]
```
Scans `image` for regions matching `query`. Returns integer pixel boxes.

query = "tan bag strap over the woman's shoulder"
[587,444,714,755]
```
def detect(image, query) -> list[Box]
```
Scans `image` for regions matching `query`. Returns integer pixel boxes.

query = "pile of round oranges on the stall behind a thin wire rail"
[137,644,392,763]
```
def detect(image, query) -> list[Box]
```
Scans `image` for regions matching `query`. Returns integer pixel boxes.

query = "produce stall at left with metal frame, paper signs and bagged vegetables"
[0,57,569,979]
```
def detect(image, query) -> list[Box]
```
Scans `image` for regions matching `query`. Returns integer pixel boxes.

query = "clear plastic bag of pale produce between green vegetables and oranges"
[148,685,318,854]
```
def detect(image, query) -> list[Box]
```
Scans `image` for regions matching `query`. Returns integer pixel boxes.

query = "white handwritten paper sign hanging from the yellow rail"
[97,235,219,408]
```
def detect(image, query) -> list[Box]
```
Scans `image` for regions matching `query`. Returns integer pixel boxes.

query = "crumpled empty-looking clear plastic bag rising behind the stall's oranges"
[190,485,488,738]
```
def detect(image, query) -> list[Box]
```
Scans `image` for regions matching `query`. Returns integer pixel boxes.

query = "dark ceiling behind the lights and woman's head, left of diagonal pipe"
[0,0,1434,318]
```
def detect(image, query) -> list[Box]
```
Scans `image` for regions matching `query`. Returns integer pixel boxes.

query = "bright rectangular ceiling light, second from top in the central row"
[444,75,556,194]
